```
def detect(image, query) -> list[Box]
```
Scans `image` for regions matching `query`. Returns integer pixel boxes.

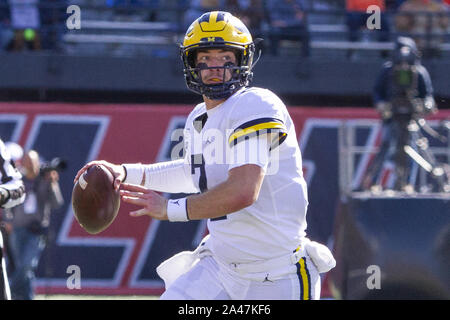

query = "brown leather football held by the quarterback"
[72,165,120,234]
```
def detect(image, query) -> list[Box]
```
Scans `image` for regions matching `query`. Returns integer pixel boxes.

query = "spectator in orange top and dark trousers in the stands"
[346,0,390,41]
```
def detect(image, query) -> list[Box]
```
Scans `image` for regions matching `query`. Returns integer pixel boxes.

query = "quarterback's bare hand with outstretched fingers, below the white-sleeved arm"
[120,183,168,220]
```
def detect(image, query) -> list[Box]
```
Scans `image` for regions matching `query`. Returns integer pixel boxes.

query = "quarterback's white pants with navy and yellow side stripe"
[161,256,321,300]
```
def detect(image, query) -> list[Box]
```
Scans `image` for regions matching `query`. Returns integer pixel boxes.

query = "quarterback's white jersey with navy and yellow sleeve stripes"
[184,87,308,263]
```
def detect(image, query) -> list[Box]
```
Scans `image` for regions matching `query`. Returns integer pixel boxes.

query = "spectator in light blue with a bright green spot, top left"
[9,0,41,51]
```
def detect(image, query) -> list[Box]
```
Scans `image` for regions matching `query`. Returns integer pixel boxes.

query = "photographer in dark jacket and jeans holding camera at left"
[7,150,64,300]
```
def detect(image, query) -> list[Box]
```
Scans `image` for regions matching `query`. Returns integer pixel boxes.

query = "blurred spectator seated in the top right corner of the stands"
[395,0,449,57]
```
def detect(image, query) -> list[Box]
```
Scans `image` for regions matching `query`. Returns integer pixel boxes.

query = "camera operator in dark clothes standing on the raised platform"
[362,37,436,191]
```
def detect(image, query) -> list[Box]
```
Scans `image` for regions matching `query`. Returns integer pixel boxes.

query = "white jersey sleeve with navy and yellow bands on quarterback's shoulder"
[227,89,288,149]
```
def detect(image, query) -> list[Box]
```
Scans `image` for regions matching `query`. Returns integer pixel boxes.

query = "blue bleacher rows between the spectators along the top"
[0,0,444,58]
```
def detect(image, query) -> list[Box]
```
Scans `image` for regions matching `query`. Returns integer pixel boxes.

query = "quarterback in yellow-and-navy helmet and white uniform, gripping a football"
[75,11,334,300]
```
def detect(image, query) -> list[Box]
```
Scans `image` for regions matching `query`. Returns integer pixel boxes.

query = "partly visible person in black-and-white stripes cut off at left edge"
[0,139,25,300]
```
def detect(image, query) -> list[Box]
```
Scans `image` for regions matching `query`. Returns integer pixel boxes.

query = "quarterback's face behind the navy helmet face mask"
[196,49,236,84]
